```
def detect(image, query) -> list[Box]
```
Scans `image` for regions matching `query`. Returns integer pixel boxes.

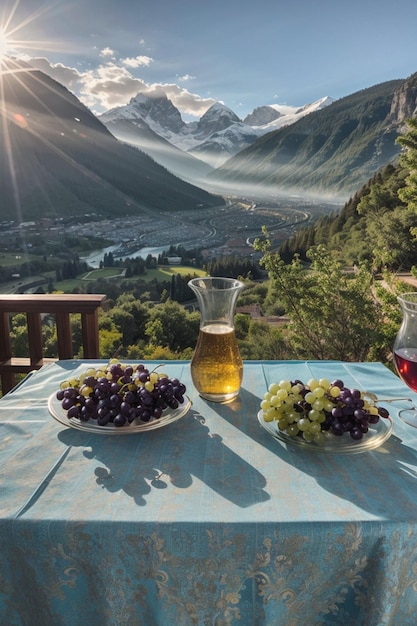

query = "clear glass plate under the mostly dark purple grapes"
[48,393,191,435]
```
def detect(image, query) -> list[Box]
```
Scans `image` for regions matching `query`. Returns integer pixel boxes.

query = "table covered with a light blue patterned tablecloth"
[0,361,417,626]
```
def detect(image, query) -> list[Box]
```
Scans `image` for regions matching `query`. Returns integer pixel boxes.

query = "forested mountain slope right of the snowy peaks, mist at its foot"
[208,74,417,200]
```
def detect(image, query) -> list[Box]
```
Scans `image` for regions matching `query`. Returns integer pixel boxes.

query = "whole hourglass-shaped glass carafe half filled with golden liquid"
[188,277,244,402]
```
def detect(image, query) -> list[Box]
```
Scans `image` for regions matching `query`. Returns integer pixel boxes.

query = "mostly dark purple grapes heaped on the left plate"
[56,361,186,426]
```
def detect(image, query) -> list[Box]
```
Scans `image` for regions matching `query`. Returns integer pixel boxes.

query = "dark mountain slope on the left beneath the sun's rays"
[0,59,224,222]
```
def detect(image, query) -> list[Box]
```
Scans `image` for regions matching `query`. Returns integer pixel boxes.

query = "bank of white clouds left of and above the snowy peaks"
[25,54,215,117]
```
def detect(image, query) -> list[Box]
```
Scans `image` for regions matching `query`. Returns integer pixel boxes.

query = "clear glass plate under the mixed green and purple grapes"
[258,409,393,453]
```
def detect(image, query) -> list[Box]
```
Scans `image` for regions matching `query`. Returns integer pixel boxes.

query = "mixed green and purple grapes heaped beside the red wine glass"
[261,378,388,444]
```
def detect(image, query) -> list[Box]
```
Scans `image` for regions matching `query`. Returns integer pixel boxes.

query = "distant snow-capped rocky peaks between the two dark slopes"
[99,90,332,173]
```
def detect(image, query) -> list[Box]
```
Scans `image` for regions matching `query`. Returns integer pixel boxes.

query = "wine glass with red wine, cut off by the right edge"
[393,291,417,428]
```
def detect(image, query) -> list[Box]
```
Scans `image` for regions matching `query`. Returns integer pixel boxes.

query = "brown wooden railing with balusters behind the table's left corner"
[0,294,106,394]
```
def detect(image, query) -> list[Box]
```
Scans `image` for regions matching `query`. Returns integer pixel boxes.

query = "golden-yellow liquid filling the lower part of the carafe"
[191,324,243,402]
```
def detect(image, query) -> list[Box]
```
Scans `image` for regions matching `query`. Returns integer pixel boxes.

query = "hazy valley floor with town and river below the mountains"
[0,197,340,293]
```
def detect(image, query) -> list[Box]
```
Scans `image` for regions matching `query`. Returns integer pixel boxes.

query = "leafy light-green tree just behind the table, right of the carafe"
[255,235,388,361]
